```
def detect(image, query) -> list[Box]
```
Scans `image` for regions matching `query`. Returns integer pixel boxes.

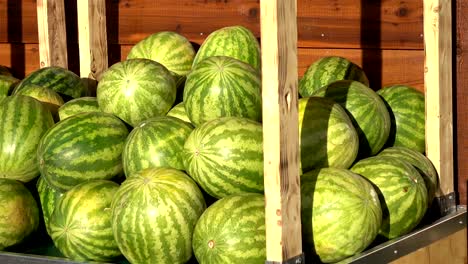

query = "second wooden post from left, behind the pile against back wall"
[77,0,108,93]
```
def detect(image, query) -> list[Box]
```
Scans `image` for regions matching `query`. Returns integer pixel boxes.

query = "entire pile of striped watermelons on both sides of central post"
[0,26,438,264]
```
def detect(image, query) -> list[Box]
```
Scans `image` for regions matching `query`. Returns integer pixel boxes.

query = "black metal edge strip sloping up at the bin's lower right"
[340,205,467,264]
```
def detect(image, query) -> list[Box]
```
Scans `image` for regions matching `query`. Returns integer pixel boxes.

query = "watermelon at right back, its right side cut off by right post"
[377,85,426,153]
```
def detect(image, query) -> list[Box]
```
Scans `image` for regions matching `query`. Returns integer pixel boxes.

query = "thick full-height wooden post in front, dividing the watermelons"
[260,0,303,263]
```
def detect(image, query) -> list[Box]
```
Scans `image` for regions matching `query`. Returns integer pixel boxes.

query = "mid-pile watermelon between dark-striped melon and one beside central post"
[122,116,193,177]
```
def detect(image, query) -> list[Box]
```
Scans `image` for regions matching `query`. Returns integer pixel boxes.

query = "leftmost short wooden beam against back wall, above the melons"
[37,0,68,68]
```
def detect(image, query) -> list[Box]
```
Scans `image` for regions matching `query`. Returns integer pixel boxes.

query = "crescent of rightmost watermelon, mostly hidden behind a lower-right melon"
[379,147,439,208]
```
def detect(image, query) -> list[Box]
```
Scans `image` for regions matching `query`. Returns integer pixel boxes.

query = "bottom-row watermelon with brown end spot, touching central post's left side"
[192,193,266,264]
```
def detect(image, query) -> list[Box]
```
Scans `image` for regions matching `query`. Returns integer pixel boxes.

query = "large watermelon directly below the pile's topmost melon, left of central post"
[184,56,262,126]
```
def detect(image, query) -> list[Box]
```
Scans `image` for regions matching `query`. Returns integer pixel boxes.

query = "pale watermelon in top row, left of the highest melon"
[127,31,195,81]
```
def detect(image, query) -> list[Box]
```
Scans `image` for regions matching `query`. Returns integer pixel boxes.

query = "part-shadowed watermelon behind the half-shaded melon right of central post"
[314,80,391,157]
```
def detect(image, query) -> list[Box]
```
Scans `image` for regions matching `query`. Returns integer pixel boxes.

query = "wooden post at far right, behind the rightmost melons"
[424,0,456,214]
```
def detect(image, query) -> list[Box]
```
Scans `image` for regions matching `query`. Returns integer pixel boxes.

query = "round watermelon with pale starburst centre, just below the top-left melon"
[96,59,176,126]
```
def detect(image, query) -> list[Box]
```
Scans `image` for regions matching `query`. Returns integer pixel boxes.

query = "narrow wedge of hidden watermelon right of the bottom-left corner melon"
[36,176,63,235]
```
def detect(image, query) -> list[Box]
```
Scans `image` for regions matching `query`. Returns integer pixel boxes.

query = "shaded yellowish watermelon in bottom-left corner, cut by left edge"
[0,179,39,250]
